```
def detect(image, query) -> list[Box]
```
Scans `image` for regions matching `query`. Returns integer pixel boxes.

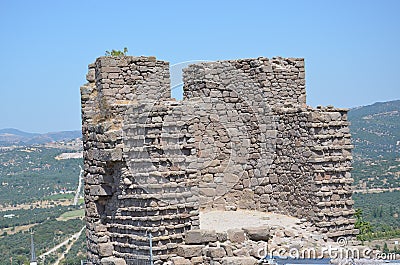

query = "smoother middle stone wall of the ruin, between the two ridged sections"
[180,58,315,216]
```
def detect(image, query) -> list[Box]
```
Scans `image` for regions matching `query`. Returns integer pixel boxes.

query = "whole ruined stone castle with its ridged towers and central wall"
[81,56,358,264]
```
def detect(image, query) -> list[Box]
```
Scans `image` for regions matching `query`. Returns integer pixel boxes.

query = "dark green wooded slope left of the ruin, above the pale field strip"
[0,146,82,206]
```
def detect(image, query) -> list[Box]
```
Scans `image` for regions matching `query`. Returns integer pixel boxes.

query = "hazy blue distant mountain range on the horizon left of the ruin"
[0,128,82,146]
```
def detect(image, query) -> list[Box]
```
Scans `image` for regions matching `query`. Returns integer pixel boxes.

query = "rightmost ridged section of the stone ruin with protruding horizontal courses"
[309,107,358,238]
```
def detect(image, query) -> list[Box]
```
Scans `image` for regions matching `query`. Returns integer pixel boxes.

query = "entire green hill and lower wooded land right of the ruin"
[349,100,400,232]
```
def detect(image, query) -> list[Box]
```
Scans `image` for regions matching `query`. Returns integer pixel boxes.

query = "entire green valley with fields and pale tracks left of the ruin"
[0,139,84,264]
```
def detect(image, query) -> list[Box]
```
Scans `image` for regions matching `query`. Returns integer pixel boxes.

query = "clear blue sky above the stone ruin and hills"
[0,0,400,132]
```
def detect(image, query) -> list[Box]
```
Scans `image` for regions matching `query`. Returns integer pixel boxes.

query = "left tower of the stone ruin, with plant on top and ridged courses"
[81,57,198,264]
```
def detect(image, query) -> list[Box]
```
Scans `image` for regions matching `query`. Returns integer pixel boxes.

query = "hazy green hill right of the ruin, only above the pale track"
[349,100,400,189]
